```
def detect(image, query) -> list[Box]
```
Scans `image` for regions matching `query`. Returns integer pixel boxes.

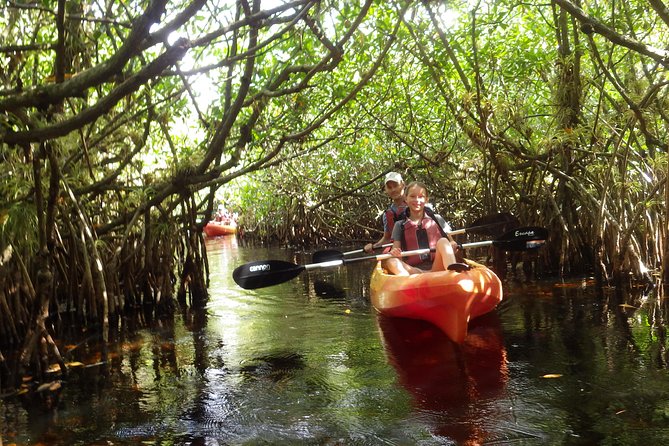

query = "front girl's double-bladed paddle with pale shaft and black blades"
[232,226,548,290]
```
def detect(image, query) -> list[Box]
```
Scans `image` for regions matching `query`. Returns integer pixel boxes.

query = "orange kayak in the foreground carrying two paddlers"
[370,260,502,343]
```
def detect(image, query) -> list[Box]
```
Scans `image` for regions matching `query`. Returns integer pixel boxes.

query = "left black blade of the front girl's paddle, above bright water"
[232,260,305,290]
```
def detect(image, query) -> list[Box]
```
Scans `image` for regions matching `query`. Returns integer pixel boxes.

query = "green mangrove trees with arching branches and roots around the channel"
[0,0,669,395]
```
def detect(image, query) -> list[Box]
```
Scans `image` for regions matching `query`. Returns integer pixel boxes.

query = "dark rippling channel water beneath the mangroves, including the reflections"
[0,237,669,446]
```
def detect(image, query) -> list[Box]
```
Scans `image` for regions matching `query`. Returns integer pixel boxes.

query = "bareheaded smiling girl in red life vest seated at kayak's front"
[383,181,457,276]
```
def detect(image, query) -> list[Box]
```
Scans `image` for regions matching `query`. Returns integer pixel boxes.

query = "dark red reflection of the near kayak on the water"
[378,313,508,445]
